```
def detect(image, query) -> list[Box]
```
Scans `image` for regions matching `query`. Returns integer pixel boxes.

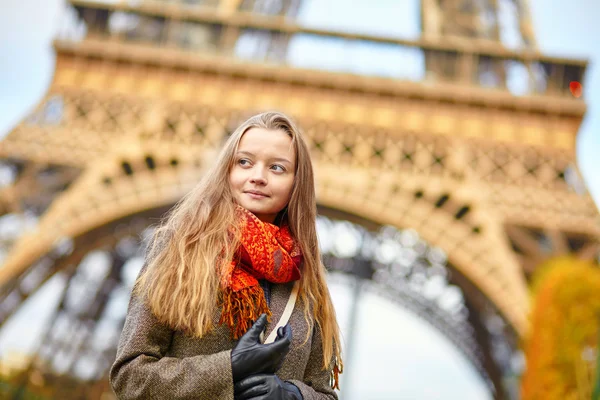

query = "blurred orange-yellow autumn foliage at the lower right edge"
[521,257,600,400]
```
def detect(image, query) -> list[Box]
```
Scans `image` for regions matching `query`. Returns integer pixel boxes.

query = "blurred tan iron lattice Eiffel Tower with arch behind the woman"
[0,0,600,399]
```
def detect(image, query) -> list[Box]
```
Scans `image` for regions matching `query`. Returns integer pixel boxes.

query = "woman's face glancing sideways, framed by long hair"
[229,128,296,223]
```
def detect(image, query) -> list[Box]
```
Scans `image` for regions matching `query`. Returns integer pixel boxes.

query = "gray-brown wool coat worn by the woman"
[110,283,337,400]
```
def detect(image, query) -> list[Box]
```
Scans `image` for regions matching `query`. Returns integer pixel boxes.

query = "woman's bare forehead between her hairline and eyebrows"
[237,128,295,161]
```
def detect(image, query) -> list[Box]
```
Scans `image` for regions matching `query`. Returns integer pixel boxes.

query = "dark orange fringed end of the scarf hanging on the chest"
[219,286,271,340]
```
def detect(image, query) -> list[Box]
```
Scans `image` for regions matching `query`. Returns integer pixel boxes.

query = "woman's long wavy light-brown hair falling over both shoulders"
[134,112,342,378]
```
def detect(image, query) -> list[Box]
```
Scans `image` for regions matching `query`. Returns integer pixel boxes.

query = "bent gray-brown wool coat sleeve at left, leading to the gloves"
[109,290,233,400]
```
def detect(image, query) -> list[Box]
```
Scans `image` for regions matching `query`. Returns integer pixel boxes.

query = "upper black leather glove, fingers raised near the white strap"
[231,314,292,383]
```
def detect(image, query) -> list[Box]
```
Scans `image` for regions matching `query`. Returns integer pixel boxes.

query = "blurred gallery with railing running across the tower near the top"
[58,0,587,99]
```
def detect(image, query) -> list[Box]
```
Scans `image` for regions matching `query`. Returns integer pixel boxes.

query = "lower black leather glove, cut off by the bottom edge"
[234,374,304,400]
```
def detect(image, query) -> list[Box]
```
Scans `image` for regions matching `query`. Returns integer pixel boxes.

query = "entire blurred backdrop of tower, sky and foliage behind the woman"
[0,0,600,400]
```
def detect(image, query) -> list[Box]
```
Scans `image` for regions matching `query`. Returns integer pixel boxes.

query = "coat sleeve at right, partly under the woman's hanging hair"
[289,326,338,400]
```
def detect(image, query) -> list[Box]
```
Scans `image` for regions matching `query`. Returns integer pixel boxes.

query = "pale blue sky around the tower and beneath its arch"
[0,0,600,400]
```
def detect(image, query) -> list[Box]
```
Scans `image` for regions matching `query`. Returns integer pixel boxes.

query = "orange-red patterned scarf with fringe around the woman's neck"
[219,206,302,339]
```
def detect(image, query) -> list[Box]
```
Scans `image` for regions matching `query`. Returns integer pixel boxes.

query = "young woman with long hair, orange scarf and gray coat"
[110,112,342,400]
